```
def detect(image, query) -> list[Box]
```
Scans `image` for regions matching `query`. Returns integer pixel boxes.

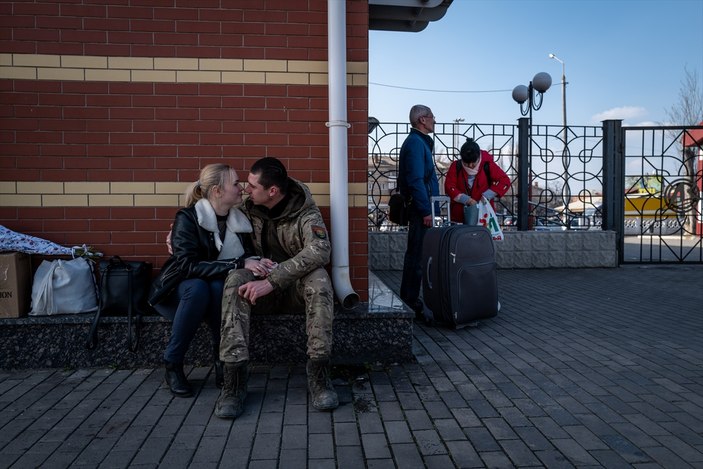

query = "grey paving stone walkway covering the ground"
[0,266,703,469]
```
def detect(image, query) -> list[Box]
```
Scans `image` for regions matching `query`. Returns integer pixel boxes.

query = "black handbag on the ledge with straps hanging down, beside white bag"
[86,256,152,352]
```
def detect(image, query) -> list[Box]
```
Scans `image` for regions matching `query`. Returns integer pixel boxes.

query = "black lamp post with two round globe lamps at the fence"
[513,72,552,231]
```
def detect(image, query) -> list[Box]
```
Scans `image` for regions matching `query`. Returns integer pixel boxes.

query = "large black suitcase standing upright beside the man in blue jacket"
[422,202,498,329]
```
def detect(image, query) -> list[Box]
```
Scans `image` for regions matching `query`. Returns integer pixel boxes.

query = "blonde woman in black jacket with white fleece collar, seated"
[149,164,276,397]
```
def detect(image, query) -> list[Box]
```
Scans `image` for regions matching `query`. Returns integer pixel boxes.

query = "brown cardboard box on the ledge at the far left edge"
[0,252,32,318]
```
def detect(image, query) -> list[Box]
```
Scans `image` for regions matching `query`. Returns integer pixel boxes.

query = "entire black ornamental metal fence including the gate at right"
[368,118,703,262]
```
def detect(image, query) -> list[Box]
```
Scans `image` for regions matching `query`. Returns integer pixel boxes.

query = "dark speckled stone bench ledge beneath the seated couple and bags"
[0,273,414,369]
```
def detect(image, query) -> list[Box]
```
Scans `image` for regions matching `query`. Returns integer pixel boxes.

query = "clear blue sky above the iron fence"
[369,0,703,125]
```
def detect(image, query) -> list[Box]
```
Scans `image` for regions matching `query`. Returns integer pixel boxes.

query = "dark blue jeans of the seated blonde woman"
[154,278,225,363]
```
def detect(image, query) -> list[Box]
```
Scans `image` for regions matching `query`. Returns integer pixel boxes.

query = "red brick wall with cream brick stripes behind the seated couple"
[0,0,368,297]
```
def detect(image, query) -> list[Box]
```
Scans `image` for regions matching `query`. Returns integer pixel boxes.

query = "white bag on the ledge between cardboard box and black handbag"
[29,257,98,316]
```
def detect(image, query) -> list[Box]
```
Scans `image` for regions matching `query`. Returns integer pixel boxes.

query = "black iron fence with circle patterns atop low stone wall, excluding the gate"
[368,122,602,231]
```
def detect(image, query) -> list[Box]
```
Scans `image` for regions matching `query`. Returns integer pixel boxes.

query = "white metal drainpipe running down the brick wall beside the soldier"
[326,0,359,308]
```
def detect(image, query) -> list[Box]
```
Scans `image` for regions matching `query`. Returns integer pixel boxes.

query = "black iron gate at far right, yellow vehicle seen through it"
[621,127,703,263]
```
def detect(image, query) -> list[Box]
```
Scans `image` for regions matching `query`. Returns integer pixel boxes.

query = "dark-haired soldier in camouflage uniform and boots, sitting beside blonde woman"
[215,157,339,419]
